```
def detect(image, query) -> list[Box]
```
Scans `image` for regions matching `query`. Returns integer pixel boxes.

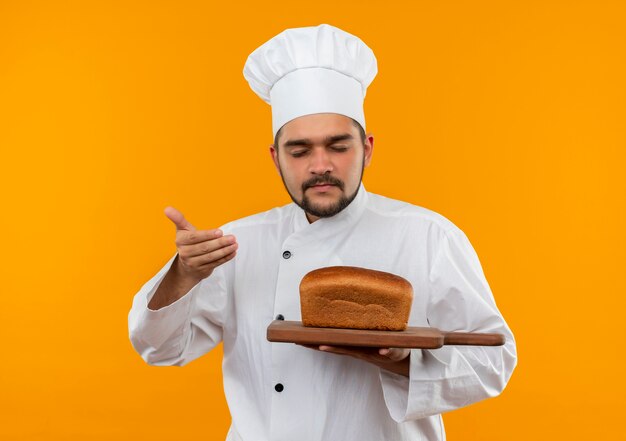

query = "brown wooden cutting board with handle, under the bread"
[267,320,505,349]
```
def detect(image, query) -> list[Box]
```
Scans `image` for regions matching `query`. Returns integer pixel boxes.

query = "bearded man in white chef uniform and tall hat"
[129,24,517,441]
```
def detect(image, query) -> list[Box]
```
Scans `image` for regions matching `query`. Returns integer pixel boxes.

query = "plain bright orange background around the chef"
[0,0,626,441]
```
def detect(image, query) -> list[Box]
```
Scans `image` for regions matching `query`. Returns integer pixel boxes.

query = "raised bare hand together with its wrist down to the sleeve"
[148,207,238,310]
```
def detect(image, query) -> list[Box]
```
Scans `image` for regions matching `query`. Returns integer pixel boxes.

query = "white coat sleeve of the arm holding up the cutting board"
[380,225,517,422]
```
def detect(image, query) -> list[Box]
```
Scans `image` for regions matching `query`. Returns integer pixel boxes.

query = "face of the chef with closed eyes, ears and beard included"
[270,113,374,222]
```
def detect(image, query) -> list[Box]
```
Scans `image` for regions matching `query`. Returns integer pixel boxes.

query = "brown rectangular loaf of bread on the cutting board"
[300,266,413,331]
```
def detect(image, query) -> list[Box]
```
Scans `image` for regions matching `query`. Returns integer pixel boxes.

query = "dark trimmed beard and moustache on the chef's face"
[280,158,365,218]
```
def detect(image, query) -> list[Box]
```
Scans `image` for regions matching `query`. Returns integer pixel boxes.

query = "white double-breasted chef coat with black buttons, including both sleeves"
[129,184,517,441]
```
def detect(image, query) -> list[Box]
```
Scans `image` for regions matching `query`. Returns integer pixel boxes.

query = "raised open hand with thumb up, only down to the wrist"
[165,207,238,283]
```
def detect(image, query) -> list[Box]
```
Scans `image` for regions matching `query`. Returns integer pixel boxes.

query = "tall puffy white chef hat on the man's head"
[243,24,378,136]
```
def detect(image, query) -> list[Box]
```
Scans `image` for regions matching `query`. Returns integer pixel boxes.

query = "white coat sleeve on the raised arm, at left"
[128,255,232,366]
